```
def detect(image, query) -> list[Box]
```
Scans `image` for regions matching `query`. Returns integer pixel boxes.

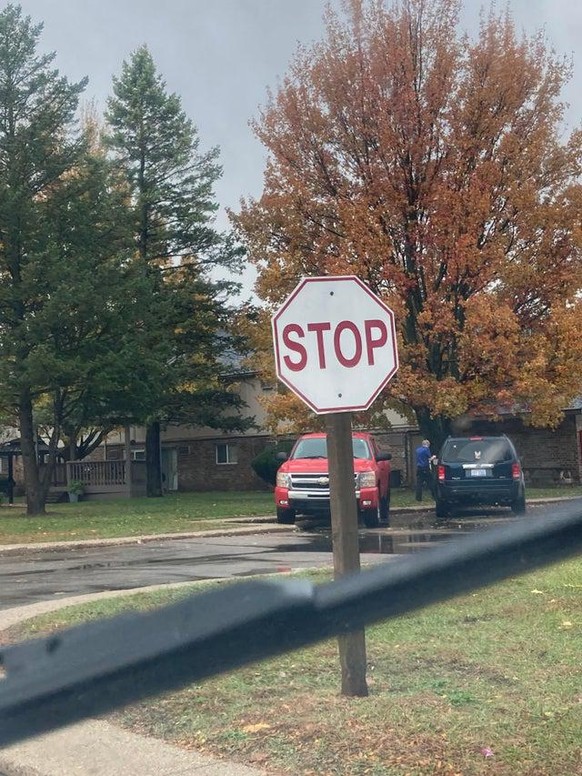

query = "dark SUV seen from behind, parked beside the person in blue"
[435,435,525,518]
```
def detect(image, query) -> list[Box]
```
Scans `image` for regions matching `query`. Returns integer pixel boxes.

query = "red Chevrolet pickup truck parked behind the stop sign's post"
[275,432,392,528]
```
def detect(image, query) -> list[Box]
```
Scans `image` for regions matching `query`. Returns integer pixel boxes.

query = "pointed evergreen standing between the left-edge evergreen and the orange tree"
[105,46,248,496]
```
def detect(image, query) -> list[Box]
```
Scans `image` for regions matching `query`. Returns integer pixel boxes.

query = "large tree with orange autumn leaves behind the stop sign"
[234,0,582,442]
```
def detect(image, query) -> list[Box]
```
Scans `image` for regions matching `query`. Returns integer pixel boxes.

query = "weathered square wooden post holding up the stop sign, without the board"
[326,412,368,697]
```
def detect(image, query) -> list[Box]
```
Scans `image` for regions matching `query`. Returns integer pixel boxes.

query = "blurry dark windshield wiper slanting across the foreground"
[0,499,582,745]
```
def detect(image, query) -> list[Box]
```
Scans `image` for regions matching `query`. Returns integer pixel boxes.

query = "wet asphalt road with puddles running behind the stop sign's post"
[0,513,528,609]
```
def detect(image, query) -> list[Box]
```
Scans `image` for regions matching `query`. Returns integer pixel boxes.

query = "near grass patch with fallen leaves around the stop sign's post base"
[10,560,582,776]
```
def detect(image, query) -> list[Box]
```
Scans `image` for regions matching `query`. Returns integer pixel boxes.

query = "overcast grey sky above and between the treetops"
[11,0,582,294]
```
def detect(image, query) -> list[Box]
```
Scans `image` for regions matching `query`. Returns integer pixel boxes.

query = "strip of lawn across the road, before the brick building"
[0,487,582,545]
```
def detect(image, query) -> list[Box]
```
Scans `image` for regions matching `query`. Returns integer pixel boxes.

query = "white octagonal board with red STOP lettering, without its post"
[272,275,398,413]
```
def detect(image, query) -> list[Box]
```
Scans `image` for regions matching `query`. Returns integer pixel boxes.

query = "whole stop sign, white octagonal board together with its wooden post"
[272,275,398,696]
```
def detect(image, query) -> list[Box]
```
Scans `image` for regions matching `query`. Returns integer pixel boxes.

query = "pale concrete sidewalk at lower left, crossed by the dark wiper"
[0,582,274,776]
